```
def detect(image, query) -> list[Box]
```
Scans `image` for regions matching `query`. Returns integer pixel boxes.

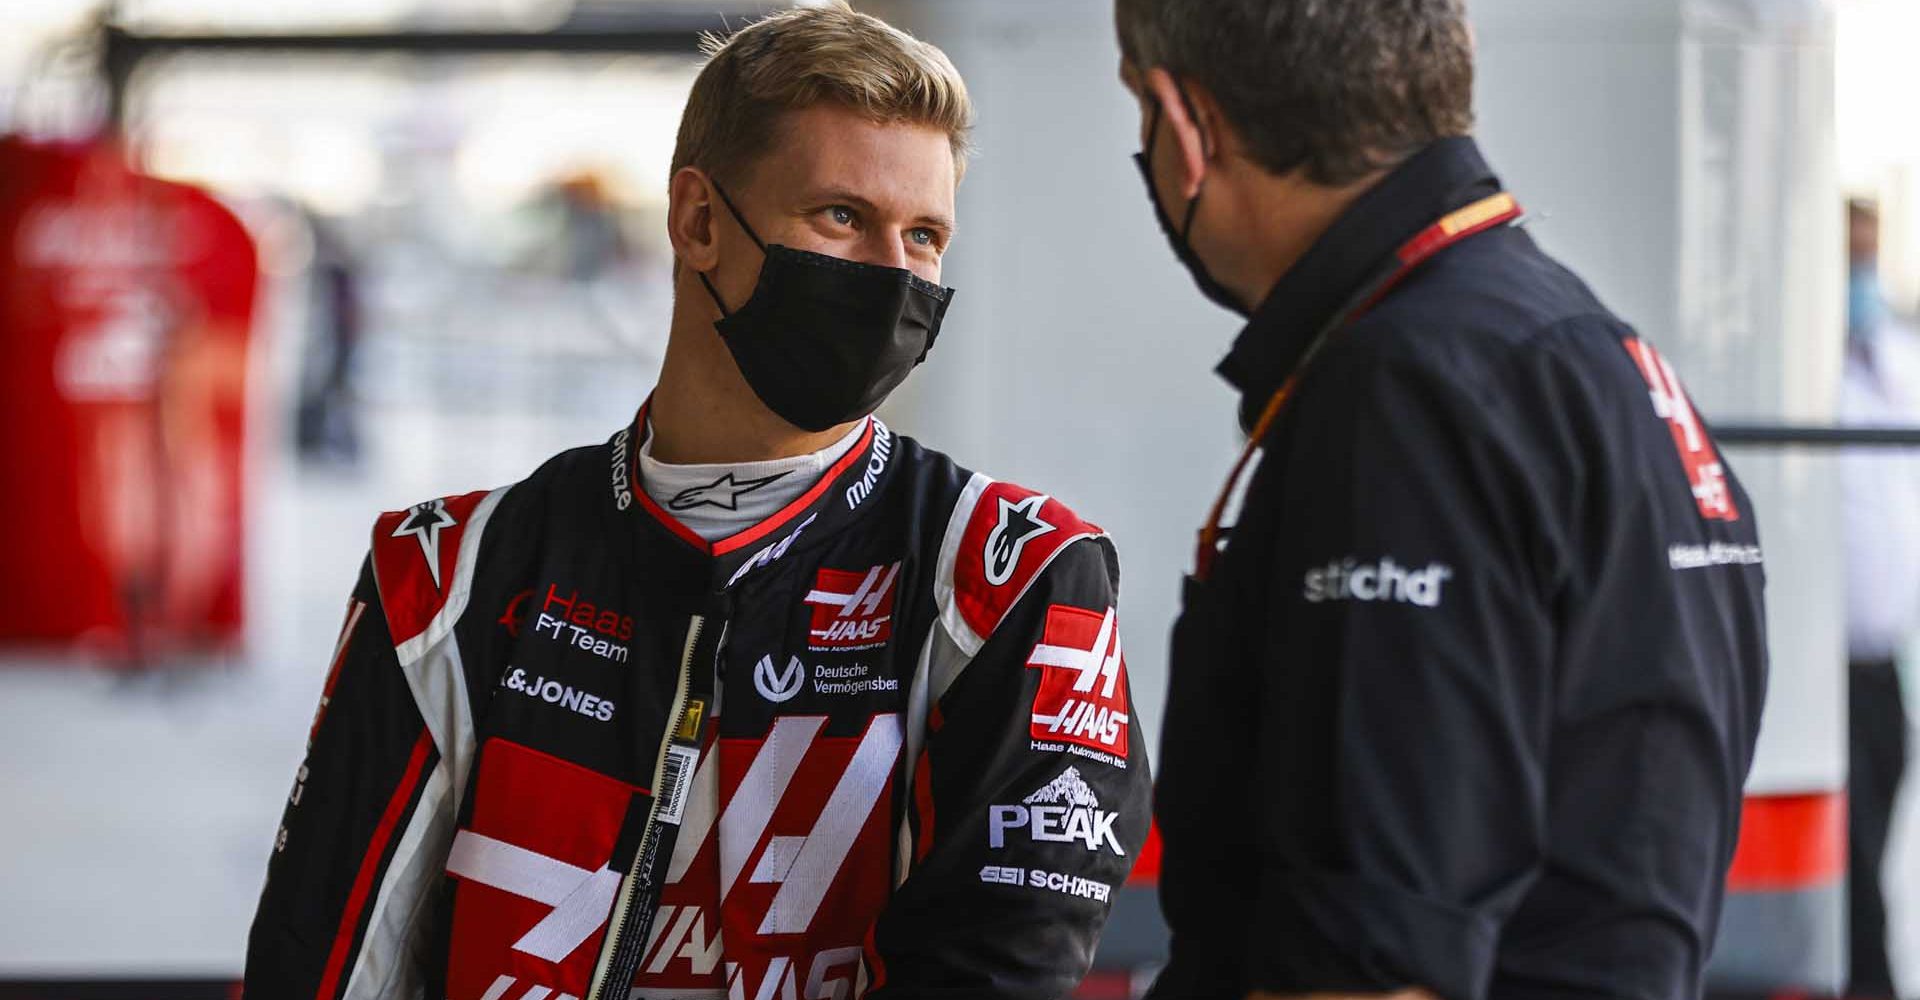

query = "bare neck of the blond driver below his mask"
[647,307,852,464]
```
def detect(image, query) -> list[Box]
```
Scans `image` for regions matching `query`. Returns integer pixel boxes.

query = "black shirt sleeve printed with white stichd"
[1251,361,1567,1000]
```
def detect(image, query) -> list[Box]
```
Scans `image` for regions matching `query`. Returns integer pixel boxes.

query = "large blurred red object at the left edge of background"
[0,138,259,655]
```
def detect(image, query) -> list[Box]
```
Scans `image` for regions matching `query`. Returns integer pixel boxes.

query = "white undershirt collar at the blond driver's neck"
[639,418,872,541]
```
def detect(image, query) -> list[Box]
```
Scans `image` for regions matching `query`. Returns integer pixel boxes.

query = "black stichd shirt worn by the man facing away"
[1154,138,1766,1000]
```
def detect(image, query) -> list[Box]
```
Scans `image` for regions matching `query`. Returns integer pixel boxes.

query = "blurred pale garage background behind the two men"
[0,0,1920,1000]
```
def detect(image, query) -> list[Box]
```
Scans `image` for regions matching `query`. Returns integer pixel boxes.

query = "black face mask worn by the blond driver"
[699,184,954,430]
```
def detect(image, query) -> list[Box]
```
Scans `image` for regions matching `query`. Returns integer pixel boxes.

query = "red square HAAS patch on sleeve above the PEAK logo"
[1027,605,1129,760]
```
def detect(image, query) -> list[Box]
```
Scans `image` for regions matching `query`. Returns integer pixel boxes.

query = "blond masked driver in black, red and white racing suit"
[246,6,1150,1000]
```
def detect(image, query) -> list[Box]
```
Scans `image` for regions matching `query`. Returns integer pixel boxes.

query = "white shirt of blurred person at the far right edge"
[1839,322,1920,660]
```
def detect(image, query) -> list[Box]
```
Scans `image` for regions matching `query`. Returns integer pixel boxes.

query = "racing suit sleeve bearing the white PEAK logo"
[872,537,1152,1000]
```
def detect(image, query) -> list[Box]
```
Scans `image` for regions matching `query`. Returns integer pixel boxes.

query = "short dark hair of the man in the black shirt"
[1116,0,1473,186]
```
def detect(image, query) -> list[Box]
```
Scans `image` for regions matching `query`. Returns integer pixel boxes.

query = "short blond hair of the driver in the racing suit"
[674,0,973,180]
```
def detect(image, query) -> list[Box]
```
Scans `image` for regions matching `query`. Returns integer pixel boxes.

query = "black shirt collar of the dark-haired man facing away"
[1215,136,1500,430]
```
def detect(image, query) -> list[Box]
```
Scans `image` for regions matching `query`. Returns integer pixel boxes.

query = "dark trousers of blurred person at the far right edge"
[1847,660,1907,996]
